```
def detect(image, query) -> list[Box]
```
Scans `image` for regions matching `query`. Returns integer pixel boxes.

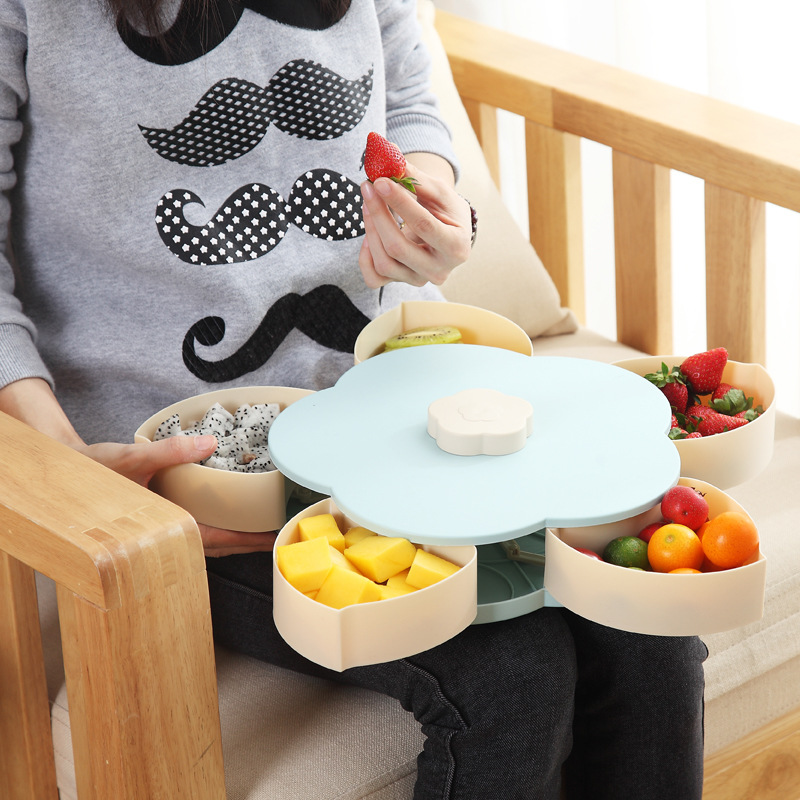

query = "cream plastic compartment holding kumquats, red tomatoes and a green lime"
[544,478,767,636]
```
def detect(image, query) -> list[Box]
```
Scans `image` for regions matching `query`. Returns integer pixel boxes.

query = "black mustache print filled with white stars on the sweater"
[156,169,364,266]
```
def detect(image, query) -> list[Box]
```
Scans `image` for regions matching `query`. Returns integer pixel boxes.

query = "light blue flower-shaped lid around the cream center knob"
[269,344,680,545]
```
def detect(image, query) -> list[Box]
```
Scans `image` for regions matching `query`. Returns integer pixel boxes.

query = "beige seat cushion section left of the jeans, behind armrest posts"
[37,576,423,800]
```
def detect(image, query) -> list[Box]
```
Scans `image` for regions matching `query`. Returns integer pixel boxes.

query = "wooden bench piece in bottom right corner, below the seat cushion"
[703,708,800,800]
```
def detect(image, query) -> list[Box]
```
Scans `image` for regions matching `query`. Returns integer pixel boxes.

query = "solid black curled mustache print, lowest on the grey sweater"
[183,284,369,383]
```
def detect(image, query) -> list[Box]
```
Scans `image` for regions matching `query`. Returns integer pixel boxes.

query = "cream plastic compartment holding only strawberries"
[616,356,775,489]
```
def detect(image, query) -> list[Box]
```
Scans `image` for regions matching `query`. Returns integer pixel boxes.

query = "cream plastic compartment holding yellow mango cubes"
[273,499,477,671]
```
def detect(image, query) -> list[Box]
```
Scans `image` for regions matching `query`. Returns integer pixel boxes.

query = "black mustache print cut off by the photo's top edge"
[117,0,350,67]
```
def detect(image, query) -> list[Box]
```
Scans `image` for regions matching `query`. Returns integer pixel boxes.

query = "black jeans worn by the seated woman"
[207,553,707,800]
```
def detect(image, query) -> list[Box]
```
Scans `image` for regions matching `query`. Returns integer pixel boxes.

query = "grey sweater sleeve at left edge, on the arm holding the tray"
[0,0,52,387]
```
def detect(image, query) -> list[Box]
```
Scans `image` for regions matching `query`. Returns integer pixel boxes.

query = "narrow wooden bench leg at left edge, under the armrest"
[0,552,58,800]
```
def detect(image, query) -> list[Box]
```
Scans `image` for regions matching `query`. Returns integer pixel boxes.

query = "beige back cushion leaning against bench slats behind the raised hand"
[418,0,576,337]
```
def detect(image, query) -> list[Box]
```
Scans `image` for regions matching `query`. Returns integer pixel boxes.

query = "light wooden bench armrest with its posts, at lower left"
[0,414,225,800]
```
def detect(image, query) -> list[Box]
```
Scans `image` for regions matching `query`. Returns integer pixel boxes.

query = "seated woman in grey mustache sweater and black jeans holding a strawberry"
[0,0,704,800]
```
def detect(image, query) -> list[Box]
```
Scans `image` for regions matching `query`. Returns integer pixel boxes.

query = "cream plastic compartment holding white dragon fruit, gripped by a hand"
[134,386,311,531]
